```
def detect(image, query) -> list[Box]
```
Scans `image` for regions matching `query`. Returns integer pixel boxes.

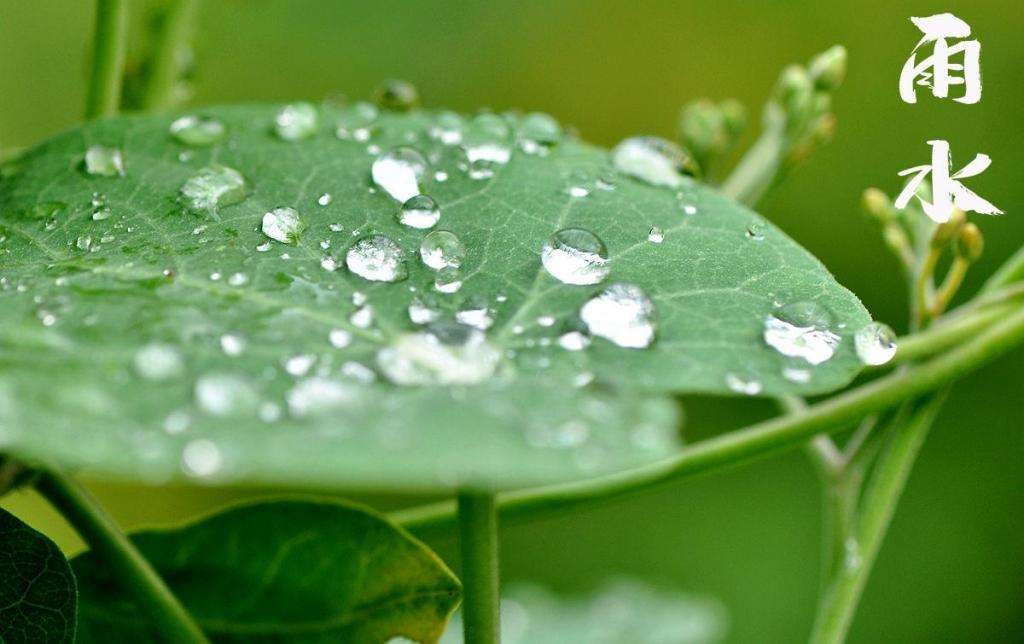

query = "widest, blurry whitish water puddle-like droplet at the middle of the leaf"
[377,324,501,385]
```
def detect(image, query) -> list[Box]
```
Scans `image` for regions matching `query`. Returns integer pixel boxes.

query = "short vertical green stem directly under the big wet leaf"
[458,491,500,644]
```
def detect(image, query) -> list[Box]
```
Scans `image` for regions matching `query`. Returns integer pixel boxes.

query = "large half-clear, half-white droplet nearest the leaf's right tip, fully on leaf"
[764,301,840,364]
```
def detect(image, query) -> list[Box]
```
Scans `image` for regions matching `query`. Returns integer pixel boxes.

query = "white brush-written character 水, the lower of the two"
[895,140,1002,223]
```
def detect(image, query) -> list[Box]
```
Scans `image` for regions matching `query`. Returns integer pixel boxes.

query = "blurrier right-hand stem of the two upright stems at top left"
[139,0,196,112]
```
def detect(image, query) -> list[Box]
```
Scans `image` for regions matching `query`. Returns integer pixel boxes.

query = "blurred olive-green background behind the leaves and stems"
[0,0,1024,643]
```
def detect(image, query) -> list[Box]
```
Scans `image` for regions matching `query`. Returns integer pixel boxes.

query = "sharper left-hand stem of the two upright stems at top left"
[85,0,125,121]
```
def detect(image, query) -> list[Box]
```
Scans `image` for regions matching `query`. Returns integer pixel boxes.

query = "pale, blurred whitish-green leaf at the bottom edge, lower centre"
[441,579,726,644]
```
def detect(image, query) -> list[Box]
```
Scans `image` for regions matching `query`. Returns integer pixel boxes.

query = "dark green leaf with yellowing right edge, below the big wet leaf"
[72,501,460,644]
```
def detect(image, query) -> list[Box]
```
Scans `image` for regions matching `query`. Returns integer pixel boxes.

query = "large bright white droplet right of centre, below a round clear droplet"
[580,284,655,349]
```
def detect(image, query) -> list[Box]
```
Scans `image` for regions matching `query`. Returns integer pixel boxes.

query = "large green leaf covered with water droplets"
[0,105,868,489]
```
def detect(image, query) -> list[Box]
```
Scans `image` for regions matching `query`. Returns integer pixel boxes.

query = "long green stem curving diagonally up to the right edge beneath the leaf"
[392,308,1024,533]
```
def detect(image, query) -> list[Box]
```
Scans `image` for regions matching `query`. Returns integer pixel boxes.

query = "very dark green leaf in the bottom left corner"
[0,510,77,644]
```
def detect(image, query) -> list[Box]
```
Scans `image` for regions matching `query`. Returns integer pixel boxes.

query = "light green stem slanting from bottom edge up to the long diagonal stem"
[810,393,945,644]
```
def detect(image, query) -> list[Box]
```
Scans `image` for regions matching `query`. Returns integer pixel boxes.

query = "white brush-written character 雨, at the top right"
[899,13,981,104]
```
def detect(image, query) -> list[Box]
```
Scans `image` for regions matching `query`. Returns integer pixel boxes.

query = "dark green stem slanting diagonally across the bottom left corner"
[35,470,209,644]
